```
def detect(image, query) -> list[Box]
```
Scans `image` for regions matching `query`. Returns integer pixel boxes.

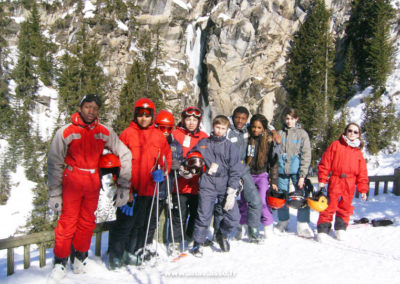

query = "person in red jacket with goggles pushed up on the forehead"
[169,106,208,251]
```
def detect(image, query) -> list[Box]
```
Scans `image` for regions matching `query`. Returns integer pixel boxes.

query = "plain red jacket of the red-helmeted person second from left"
[120,121,172,196]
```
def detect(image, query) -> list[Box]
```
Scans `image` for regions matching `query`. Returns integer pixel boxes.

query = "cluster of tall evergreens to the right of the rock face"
[283,0,399,161]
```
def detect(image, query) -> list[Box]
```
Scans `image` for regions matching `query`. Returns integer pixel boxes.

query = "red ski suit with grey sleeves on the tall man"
[48,113,132,258]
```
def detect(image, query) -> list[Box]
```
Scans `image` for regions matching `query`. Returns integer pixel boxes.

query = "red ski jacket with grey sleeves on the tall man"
[47,113,132,196]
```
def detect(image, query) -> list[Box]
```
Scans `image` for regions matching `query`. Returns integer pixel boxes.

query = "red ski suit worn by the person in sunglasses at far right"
[318,135,369,225]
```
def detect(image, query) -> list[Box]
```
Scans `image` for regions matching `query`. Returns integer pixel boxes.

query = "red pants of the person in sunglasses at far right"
[318,176,356,225]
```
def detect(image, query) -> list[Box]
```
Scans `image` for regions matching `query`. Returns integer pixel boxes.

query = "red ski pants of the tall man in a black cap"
[54,167,100,258]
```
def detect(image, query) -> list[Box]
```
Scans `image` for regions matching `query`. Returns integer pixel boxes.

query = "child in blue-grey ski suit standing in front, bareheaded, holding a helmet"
[192,115,243,257]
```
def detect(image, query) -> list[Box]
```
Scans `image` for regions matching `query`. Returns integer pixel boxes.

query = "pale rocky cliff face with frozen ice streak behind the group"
[4,0,351,128]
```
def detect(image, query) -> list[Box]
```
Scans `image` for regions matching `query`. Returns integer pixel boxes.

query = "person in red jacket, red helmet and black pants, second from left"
[109,98,172,270]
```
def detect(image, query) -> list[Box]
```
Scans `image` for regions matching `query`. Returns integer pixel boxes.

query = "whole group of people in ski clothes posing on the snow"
[48,95,368,279]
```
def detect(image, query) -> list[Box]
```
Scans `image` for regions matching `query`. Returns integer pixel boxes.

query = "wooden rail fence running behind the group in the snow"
[0,168,400,275]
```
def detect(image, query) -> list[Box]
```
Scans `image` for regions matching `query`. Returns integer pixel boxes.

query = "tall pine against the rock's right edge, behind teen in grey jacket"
[284,0,336,162]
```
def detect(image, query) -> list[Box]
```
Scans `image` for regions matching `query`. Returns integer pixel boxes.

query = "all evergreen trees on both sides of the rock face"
[0,0,400,235]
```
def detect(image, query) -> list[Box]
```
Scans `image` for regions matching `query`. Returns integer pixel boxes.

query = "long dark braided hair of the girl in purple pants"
[247,113,272,168]
